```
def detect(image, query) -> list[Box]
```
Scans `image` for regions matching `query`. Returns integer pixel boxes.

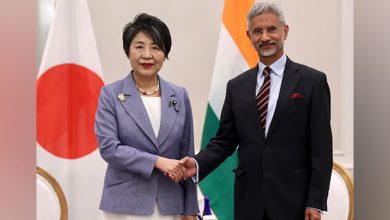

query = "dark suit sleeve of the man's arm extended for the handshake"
[194,81,238,181]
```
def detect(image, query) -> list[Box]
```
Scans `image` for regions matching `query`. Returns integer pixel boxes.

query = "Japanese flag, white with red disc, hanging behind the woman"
[36,0,106,220]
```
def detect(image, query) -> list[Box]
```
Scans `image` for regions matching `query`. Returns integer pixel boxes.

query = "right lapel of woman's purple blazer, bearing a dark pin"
[157,77,178,145]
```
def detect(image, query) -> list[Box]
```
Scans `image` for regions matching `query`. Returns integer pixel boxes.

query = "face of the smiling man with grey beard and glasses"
[247,13,288,63]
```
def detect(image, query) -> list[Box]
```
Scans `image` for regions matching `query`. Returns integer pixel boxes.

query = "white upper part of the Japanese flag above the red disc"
[37,0,103,78]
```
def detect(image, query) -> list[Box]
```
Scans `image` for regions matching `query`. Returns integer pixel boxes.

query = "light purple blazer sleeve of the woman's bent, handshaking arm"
[95,87,157,178]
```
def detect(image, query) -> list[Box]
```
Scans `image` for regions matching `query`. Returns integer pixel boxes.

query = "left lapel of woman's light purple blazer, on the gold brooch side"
[121,73,158,148]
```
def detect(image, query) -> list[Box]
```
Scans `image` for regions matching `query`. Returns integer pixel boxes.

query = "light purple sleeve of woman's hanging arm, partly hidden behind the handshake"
[180,89,198,215]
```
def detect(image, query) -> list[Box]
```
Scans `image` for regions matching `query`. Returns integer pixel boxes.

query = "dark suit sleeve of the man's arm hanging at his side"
[306,74,333,211]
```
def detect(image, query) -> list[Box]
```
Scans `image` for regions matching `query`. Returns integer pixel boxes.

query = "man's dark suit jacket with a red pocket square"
[195,58,333,220]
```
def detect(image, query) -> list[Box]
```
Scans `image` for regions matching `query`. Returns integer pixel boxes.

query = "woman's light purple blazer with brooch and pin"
[95,73,198,215]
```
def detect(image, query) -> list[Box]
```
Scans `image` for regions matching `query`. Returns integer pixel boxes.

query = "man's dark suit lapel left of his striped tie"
[243,66,265,139]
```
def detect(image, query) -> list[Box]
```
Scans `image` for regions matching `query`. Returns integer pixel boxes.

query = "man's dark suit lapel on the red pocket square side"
[267,58,299,138]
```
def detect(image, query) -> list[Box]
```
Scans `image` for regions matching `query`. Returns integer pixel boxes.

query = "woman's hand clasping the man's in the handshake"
[155,156,186,183]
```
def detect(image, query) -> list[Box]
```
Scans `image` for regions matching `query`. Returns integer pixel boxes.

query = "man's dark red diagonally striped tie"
[256,66,271,132]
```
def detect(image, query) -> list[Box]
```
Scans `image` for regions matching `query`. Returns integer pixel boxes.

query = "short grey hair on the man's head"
[247,2,286,30]
